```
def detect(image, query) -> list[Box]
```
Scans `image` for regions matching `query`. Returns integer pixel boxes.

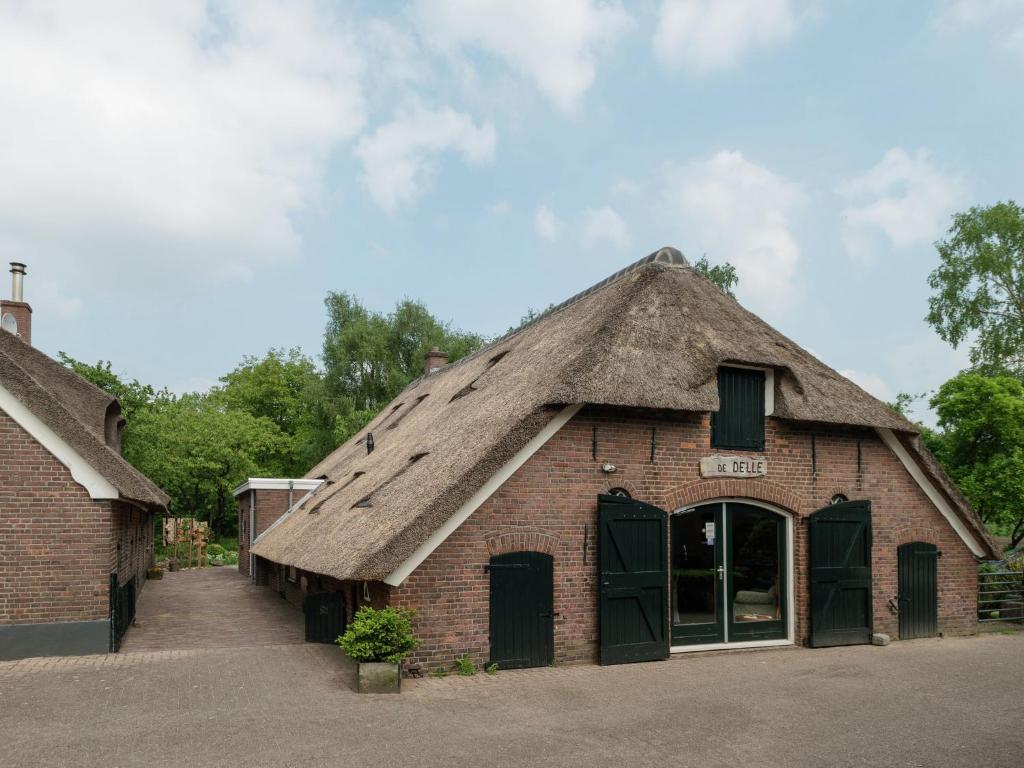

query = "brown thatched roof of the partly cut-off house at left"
[0,332,169,509]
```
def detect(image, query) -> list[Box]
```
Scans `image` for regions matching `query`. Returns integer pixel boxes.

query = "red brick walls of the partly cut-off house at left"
[0,411,153,625]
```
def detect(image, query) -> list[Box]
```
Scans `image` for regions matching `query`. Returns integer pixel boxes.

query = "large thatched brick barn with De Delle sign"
[240,249,995,668]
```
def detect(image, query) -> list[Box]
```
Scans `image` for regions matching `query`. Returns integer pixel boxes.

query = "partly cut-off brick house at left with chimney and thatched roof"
[0,264,167,659]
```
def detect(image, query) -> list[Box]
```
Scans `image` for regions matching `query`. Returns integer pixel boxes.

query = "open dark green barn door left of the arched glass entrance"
[598,496,669,664]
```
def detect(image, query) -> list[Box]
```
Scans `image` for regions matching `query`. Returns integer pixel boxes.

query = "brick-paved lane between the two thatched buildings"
[121,567,304,653]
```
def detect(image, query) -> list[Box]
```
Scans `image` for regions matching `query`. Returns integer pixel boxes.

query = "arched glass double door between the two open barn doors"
[670,502,788,646]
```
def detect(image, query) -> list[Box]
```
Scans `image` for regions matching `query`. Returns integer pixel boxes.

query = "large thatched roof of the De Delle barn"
[253,248,995,580]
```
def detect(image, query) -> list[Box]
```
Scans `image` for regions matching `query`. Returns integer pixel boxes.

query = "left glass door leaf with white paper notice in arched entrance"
[670,504,726,645]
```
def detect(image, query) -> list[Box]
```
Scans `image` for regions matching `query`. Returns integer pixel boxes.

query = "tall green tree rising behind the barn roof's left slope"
[323,292,484,444]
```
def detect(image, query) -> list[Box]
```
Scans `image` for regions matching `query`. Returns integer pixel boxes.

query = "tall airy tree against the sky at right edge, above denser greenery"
[928,201,1024,377]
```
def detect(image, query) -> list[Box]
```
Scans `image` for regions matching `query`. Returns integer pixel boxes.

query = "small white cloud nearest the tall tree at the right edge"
[837,146,967,259]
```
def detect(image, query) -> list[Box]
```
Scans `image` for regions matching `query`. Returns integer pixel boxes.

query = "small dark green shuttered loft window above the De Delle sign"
[711,368,765,451]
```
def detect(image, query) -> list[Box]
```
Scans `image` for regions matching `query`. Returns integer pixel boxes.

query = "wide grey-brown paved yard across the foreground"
[0,634,1024,768]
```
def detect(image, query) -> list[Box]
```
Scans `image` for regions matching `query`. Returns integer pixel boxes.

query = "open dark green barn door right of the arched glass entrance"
[810,502,871,648]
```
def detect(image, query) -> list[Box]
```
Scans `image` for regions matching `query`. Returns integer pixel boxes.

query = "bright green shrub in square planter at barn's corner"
[336,606,420,693]
